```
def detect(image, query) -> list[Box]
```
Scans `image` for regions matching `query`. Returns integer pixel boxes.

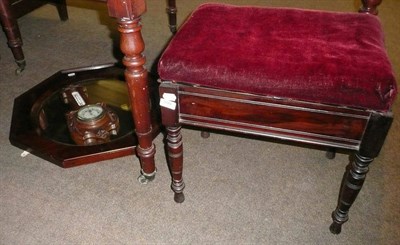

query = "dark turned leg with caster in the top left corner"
[0,0,26,74]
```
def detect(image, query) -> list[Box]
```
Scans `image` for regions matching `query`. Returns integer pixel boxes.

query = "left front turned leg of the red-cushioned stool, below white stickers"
[167,126,185,203]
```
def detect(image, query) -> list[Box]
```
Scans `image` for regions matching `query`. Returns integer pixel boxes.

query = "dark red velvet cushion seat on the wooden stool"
[158,4,397,111]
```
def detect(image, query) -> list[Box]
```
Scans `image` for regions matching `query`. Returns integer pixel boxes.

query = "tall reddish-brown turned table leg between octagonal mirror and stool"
[107,0,156,184]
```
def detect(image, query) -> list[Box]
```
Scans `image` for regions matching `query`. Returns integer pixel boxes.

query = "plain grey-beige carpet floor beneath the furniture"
[0,0,400,245]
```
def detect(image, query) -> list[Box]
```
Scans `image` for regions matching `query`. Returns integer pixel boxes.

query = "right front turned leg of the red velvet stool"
[329,153,374,234]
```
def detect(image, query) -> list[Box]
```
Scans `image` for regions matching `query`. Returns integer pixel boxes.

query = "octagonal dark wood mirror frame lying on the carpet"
[10,64,159,168]
